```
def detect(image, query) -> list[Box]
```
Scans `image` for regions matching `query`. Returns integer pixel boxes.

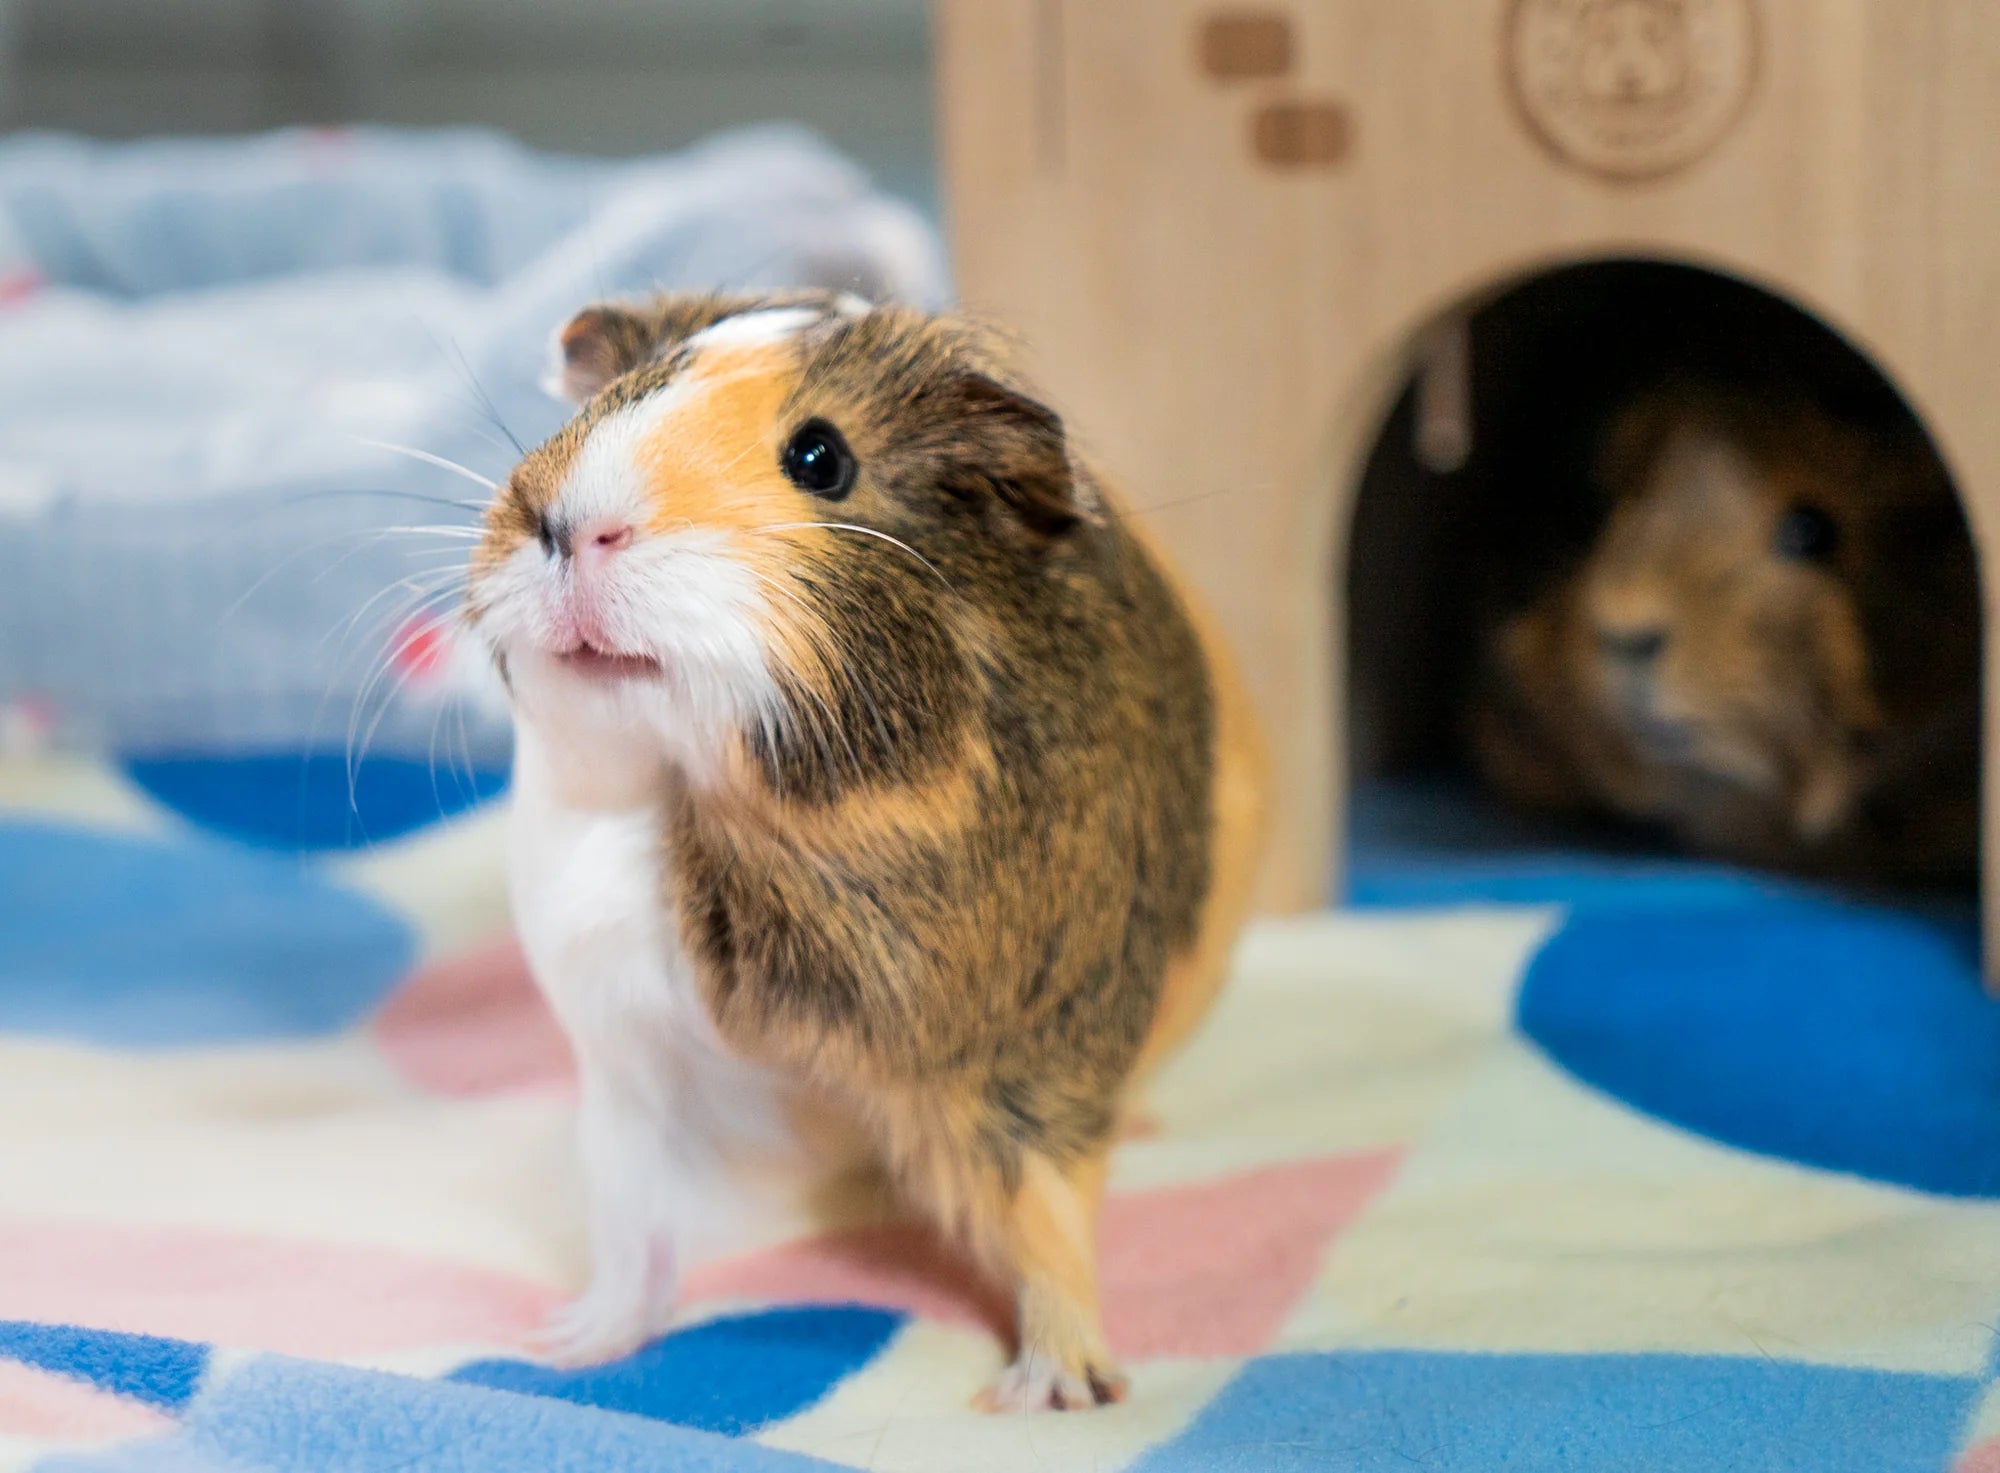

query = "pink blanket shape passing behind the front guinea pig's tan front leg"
[688,1151,1400,1359]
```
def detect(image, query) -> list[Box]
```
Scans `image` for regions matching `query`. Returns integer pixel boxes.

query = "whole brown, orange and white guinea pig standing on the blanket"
[468,294,1262,1409]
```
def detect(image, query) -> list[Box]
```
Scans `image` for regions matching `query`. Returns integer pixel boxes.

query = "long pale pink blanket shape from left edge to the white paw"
[0,1219,556,1355]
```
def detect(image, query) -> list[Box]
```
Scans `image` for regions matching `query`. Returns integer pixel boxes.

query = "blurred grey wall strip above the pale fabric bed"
[0,0,936,206]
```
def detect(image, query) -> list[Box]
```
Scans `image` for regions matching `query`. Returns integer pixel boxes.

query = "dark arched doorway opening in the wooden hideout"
[1340,260,1980,897]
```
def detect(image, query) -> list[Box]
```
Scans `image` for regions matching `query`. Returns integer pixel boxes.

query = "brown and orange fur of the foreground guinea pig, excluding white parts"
[482,288,1262,1405]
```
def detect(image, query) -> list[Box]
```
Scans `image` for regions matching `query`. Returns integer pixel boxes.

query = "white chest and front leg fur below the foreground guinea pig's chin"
[508,720,820,1359]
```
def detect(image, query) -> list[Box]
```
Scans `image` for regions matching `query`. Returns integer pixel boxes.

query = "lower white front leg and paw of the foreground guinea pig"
[538,1063,682,1365]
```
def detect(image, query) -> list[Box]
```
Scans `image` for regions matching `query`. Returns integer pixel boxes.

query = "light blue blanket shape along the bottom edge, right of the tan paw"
[1134,1351,1980,1473]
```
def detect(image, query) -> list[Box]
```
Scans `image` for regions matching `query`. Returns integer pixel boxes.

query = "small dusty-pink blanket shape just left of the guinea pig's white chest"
[370,937,576,1097]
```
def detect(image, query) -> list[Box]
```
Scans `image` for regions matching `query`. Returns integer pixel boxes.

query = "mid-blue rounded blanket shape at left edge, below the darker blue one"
[0,823,416,1047]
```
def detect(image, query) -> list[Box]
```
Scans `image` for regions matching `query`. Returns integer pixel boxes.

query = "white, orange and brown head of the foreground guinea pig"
[468,294,1086,783]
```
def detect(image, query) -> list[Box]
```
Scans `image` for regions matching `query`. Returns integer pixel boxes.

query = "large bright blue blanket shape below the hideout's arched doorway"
[1518,899,2000,1197]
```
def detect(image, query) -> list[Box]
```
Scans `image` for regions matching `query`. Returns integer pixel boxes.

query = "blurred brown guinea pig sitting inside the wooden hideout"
[1472,384,1980,883]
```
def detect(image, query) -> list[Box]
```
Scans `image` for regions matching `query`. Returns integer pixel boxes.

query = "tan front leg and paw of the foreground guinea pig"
[968,1151,1126,1411]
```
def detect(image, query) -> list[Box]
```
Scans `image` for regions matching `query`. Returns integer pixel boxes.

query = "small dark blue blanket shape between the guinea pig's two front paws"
[450,1305,902,1435]
